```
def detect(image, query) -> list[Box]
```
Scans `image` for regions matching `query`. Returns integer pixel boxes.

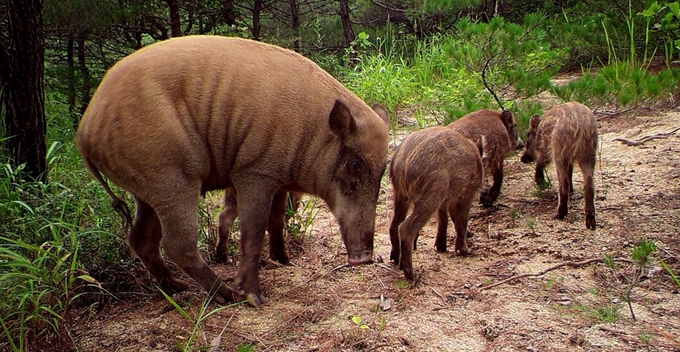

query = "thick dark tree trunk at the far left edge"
[0,0,47,182]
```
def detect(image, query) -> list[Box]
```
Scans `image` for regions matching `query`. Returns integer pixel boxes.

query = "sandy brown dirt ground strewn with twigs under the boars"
[73,110,680,352]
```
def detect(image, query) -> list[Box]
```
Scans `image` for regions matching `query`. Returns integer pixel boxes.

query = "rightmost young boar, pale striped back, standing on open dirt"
[521,102,597,230]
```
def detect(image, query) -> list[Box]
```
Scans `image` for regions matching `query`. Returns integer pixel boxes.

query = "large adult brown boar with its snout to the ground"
[76,36,389,306]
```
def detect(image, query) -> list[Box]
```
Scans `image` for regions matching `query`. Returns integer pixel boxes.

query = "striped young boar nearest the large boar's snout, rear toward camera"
[389,127,484,280]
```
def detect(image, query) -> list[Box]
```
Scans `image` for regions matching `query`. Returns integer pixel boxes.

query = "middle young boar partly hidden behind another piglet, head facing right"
[449,109,524,207]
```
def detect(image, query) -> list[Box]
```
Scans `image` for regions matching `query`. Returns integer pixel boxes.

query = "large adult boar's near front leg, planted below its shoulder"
[234,180,278,307]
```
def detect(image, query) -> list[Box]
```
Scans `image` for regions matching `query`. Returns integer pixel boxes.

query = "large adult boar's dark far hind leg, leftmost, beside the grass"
[128,198,189,293]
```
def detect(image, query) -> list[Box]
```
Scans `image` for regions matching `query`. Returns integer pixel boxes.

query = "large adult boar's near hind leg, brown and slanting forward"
[154,187,234,303]
